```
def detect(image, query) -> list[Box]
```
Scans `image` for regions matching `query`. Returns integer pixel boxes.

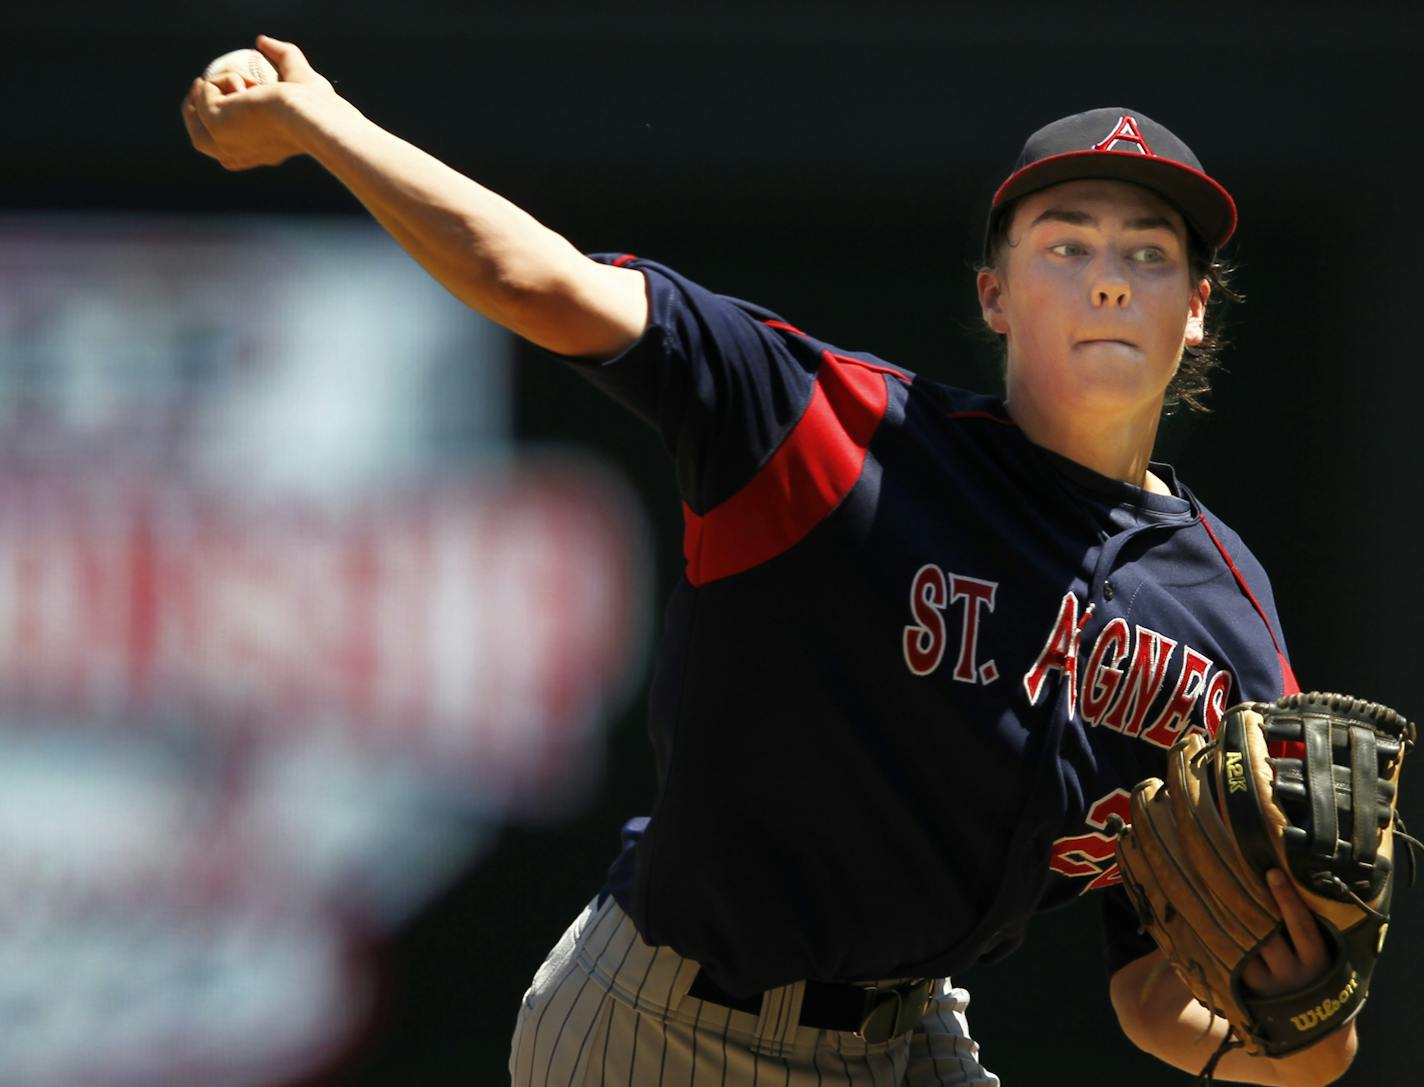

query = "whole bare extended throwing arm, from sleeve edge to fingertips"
[182,37,648,359]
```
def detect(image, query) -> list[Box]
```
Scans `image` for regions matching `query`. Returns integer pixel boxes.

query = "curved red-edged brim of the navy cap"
[990,151,1236,249]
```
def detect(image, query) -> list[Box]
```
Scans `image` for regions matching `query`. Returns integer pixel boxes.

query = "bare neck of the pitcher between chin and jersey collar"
[1005,389,1166,493]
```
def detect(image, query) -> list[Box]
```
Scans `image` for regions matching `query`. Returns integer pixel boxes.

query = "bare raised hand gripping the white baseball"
[182,34,336,170]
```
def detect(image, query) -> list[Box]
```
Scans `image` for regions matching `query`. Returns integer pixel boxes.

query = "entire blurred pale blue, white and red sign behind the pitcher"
[0,217,648,1087]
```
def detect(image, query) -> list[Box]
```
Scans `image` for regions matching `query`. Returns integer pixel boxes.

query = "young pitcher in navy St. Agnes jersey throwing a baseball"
[182,37,1413,1087]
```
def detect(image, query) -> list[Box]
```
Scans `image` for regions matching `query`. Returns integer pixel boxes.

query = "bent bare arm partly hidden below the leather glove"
[1112,953,1357,1087]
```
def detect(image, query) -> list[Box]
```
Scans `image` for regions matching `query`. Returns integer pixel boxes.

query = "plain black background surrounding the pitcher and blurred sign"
[0,0,1424,1087]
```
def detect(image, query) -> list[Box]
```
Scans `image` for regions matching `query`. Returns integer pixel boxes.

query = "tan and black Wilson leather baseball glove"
[1118,694,1415,1076]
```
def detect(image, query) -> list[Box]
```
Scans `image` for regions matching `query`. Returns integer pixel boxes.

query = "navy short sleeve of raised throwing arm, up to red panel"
[568,255,819,513]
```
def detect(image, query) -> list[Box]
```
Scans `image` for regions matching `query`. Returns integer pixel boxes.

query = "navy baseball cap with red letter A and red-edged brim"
[984,107,1236,261]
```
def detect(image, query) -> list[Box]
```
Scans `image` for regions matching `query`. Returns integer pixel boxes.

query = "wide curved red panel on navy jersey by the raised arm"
[682,350,890,586]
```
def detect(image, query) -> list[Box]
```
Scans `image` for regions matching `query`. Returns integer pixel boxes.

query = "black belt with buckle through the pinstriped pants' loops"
[688,970,936,1041]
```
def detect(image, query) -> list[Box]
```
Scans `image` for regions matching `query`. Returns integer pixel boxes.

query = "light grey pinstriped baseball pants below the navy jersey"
[510,896,998,1087]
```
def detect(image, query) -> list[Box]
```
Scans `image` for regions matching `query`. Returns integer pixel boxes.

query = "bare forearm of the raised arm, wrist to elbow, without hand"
[283,87,645,356]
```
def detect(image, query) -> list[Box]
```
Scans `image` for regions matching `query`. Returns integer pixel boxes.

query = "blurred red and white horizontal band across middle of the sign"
[0,472,642,812]
